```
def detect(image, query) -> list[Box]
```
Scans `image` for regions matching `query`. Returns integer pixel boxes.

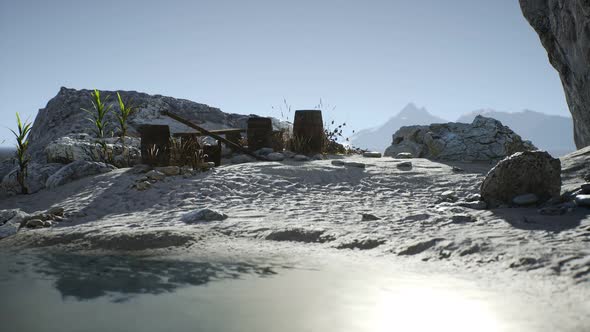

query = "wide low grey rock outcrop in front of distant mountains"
[385,116,536,161]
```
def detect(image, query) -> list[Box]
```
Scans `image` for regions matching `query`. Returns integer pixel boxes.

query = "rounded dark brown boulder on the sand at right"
[481,151,561,208]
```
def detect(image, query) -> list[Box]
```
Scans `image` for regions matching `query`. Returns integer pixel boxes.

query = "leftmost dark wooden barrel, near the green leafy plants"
[139,125,170,166]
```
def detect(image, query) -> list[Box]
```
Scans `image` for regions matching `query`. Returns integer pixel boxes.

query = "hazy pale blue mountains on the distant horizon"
[351,103,576,156]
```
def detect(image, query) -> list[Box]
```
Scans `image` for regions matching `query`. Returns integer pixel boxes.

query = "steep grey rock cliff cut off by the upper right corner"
[520,0,590,148]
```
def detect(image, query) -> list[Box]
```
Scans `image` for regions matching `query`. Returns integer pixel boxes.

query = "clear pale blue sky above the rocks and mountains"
[0,0,569,144]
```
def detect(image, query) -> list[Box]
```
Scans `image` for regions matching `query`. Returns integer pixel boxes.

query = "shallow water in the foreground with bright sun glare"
[0,254,590,332]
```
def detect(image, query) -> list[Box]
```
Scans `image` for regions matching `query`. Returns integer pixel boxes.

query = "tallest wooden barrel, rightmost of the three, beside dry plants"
[293,110,324,154]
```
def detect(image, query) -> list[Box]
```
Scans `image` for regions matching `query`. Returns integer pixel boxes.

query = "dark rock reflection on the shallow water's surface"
[35,254,277,302]
